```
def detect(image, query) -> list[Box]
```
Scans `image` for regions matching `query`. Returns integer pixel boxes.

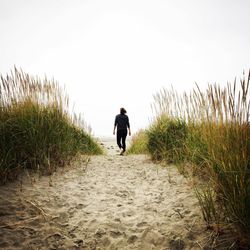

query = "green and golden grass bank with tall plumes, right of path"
[129,71,250,246]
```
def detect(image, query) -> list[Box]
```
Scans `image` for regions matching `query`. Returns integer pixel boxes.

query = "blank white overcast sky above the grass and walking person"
[0,0,250,136]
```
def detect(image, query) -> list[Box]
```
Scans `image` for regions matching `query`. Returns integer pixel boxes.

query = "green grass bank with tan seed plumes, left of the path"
[0,68,101,183]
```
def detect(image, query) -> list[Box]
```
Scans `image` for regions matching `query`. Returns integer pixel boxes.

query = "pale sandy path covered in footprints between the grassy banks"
[0,139,207,250]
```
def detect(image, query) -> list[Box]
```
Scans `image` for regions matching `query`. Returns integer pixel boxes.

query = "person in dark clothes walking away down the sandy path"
[113,108,131,155]
